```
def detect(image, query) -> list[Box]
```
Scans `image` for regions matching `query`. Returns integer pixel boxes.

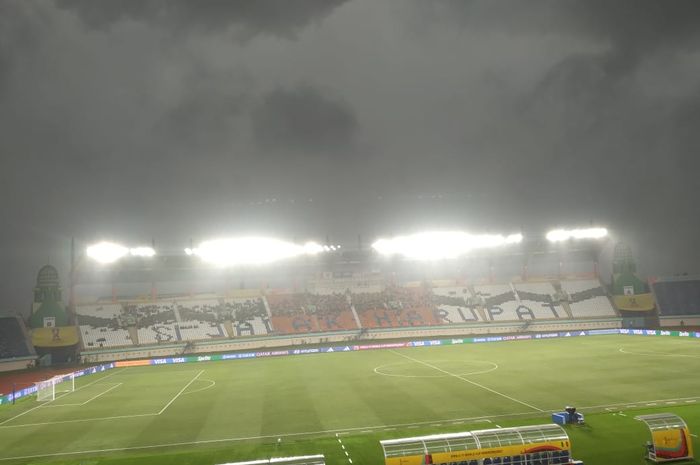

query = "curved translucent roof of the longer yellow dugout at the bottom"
[379,424,569,458]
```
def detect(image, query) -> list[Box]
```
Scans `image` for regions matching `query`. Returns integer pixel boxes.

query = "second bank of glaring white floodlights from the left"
[185,237,340,267]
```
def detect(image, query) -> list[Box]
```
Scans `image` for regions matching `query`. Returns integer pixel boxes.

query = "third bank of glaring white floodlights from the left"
[372,231,523,260]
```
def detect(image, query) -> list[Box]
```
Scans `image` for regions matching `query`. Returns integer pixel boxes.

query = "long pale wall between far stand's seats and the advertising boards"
[81,318,622,363]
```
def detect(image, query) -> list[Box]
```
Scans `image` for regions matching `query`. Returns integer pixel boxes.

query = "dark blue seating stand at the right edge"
[651,277,700,316]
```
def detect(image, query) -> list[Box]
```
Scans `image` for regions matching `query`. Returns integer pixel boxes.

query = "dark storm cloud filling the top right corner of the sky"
[421,0,700,79]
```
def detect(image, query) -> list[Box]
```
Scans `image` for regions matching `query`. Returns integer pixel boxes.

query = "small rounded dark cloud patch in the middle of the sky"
[253,85,358,155]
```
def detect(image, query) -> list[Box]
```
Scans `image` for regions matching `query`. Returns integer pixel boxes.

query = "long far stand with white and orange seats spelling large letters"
[76,279,620,348]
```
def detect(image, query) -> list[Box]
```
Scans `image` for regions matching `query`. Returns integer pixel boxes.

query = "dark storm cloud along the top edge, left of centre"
[58,0,346,37]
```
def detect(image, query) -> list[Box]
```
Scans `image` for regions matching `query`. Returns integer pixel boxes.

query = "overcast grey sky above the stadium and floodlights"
[0,0,700,310]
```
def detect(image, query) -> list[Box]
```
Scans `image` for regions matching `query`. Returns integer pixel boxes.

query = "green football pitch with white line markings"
[0,336,700,465]
